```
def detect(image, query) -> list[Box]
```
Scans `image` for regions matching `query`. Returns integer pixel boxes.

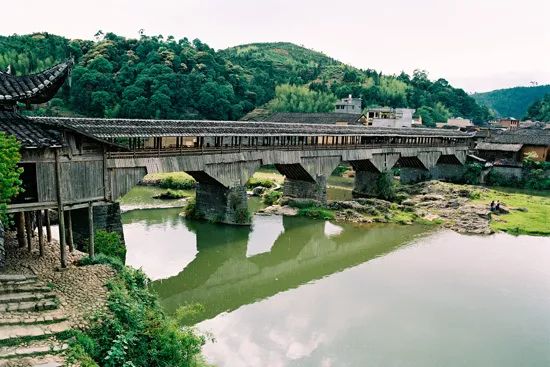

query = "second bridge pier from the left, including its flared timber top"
[275,156,342,203]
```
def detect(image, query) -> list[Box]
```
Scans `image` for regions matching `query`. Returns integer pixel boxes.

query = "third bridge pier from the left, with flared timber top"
[349,153,400,197]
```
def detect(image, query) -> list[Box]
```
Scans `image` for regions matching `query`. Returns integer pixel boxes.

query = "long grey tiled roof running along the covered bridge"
[32,117,471,139]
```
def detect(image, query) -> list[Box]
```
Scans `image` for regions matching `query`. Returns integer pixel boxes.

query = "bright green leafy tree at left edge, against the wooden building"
[0,132,23,223]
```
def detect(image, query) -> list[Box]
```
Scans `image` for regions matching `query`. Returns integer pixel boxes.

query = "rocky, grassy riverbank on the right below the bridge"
[259,181,550,235]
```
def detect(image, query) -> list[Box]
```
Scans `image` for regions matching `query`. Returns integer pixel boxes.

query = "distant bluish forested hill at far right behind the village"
[472,85,550,119]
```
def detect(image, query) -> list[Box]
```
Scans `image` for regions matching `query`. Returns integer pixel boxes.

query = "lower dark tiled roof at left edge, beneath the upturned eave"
[0,110,61,149]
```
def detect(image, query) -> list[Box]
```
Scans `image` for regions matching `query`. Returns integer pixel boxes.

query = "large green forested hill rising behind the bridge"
[0,32,490,123]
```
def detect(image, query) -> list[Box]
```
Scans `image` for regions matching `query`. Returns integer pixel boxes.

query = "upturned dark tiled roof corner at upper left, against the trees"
[0,59,73,105]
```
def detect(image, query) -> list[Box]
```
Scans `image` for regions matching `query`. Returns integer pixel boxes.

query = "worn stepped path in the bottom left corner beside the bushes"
[0,274,71,367]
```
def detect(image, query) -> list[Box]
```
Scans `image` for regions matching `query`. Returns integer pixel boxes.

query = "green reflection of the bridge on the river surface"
[124,210,436,322]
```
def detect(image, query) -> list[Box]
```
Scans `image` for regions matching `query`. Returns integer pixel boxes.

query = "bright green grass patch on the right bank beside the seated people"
[474,187,550,236]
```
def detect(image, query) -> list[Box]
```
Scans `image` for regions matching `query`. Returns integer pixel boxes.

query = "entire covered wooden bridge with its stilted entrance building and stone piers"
[0,60,471,266]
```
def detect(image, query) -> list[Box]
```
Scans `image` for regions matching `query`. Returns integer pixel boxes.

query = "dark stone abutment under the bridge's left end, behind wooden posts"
[71,203,124,251]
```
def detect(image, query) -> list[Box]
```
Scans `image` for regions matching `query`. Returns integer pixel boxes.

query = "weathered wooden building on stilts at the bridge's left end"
[0,60,113,267]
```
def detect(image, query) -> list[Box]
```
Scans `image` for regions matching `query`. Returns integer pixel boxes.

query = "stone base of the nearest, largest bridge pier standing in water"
[195,182,251,224]
